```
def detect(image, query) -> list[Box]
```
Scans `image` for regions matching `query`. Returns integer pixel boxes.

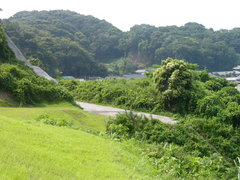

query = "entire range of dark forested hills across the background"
[4,10,240,77]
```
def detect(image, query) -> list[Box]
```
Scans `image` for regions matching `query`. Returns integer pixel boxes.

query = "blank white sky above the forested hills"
[0,0,240,31]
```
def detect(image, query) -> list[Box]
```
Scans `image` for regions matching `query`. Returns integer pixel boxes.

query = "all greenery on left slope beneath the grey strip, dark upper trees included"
[0,24,73,105]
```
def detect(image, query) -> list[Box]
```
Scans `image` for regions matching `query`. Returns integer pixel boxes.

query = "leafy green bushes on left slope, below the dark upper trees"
[0,64,73,104]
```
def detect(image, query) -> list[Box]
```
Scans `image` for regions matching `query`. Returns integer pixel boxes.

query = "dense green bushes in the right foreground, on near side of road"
[107,113,240,179]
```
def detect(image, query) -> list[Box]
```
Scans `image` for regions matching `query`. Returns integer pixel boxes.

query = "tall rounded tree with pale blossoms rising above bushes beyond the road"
[153,58,195,112]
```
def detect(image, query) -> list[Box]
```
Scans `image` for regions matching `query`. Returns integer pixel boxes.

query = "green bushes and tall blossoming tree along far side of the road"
[60,59,236,116]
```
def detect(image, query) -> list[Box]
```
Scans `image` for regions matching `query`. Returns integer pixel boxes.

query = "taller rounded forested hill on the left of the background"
[5,11,124,77]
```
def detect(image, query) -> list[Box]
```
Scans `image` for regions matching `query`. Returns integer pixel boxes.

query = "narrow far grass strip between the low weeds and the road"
[1,104,108,131]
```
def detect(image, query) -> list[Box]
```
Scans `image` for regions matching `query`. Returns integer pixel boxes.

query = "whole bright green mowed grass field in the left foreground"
[0,104,156,180]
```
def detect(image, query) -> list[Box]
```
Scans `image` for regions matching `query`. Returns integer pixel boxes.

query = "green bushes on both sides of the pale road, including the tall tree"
[60,58,240,179]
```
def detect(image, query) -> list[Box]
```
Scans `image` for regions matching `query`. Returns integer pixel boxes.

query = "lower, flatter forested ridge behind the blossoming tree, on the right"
[123,23,240,71]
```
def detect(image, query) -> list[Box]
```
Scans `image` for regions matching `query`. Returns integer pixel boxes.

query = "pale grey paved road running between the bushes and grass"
[76,101,177,124]
